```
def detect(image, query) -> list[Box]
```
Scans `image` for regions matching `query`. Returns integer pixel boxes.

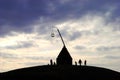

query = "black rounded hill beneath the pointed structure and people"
[0,65,120,80]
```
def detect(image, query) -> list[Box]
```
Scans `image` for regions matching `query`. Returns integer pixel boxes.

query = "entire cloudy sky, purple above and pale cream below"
[0,0,120,72]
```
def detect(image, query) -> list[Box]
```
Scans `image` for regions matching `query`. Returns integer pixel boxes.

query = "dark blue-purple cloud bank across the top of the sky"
[0,0,120,36]
